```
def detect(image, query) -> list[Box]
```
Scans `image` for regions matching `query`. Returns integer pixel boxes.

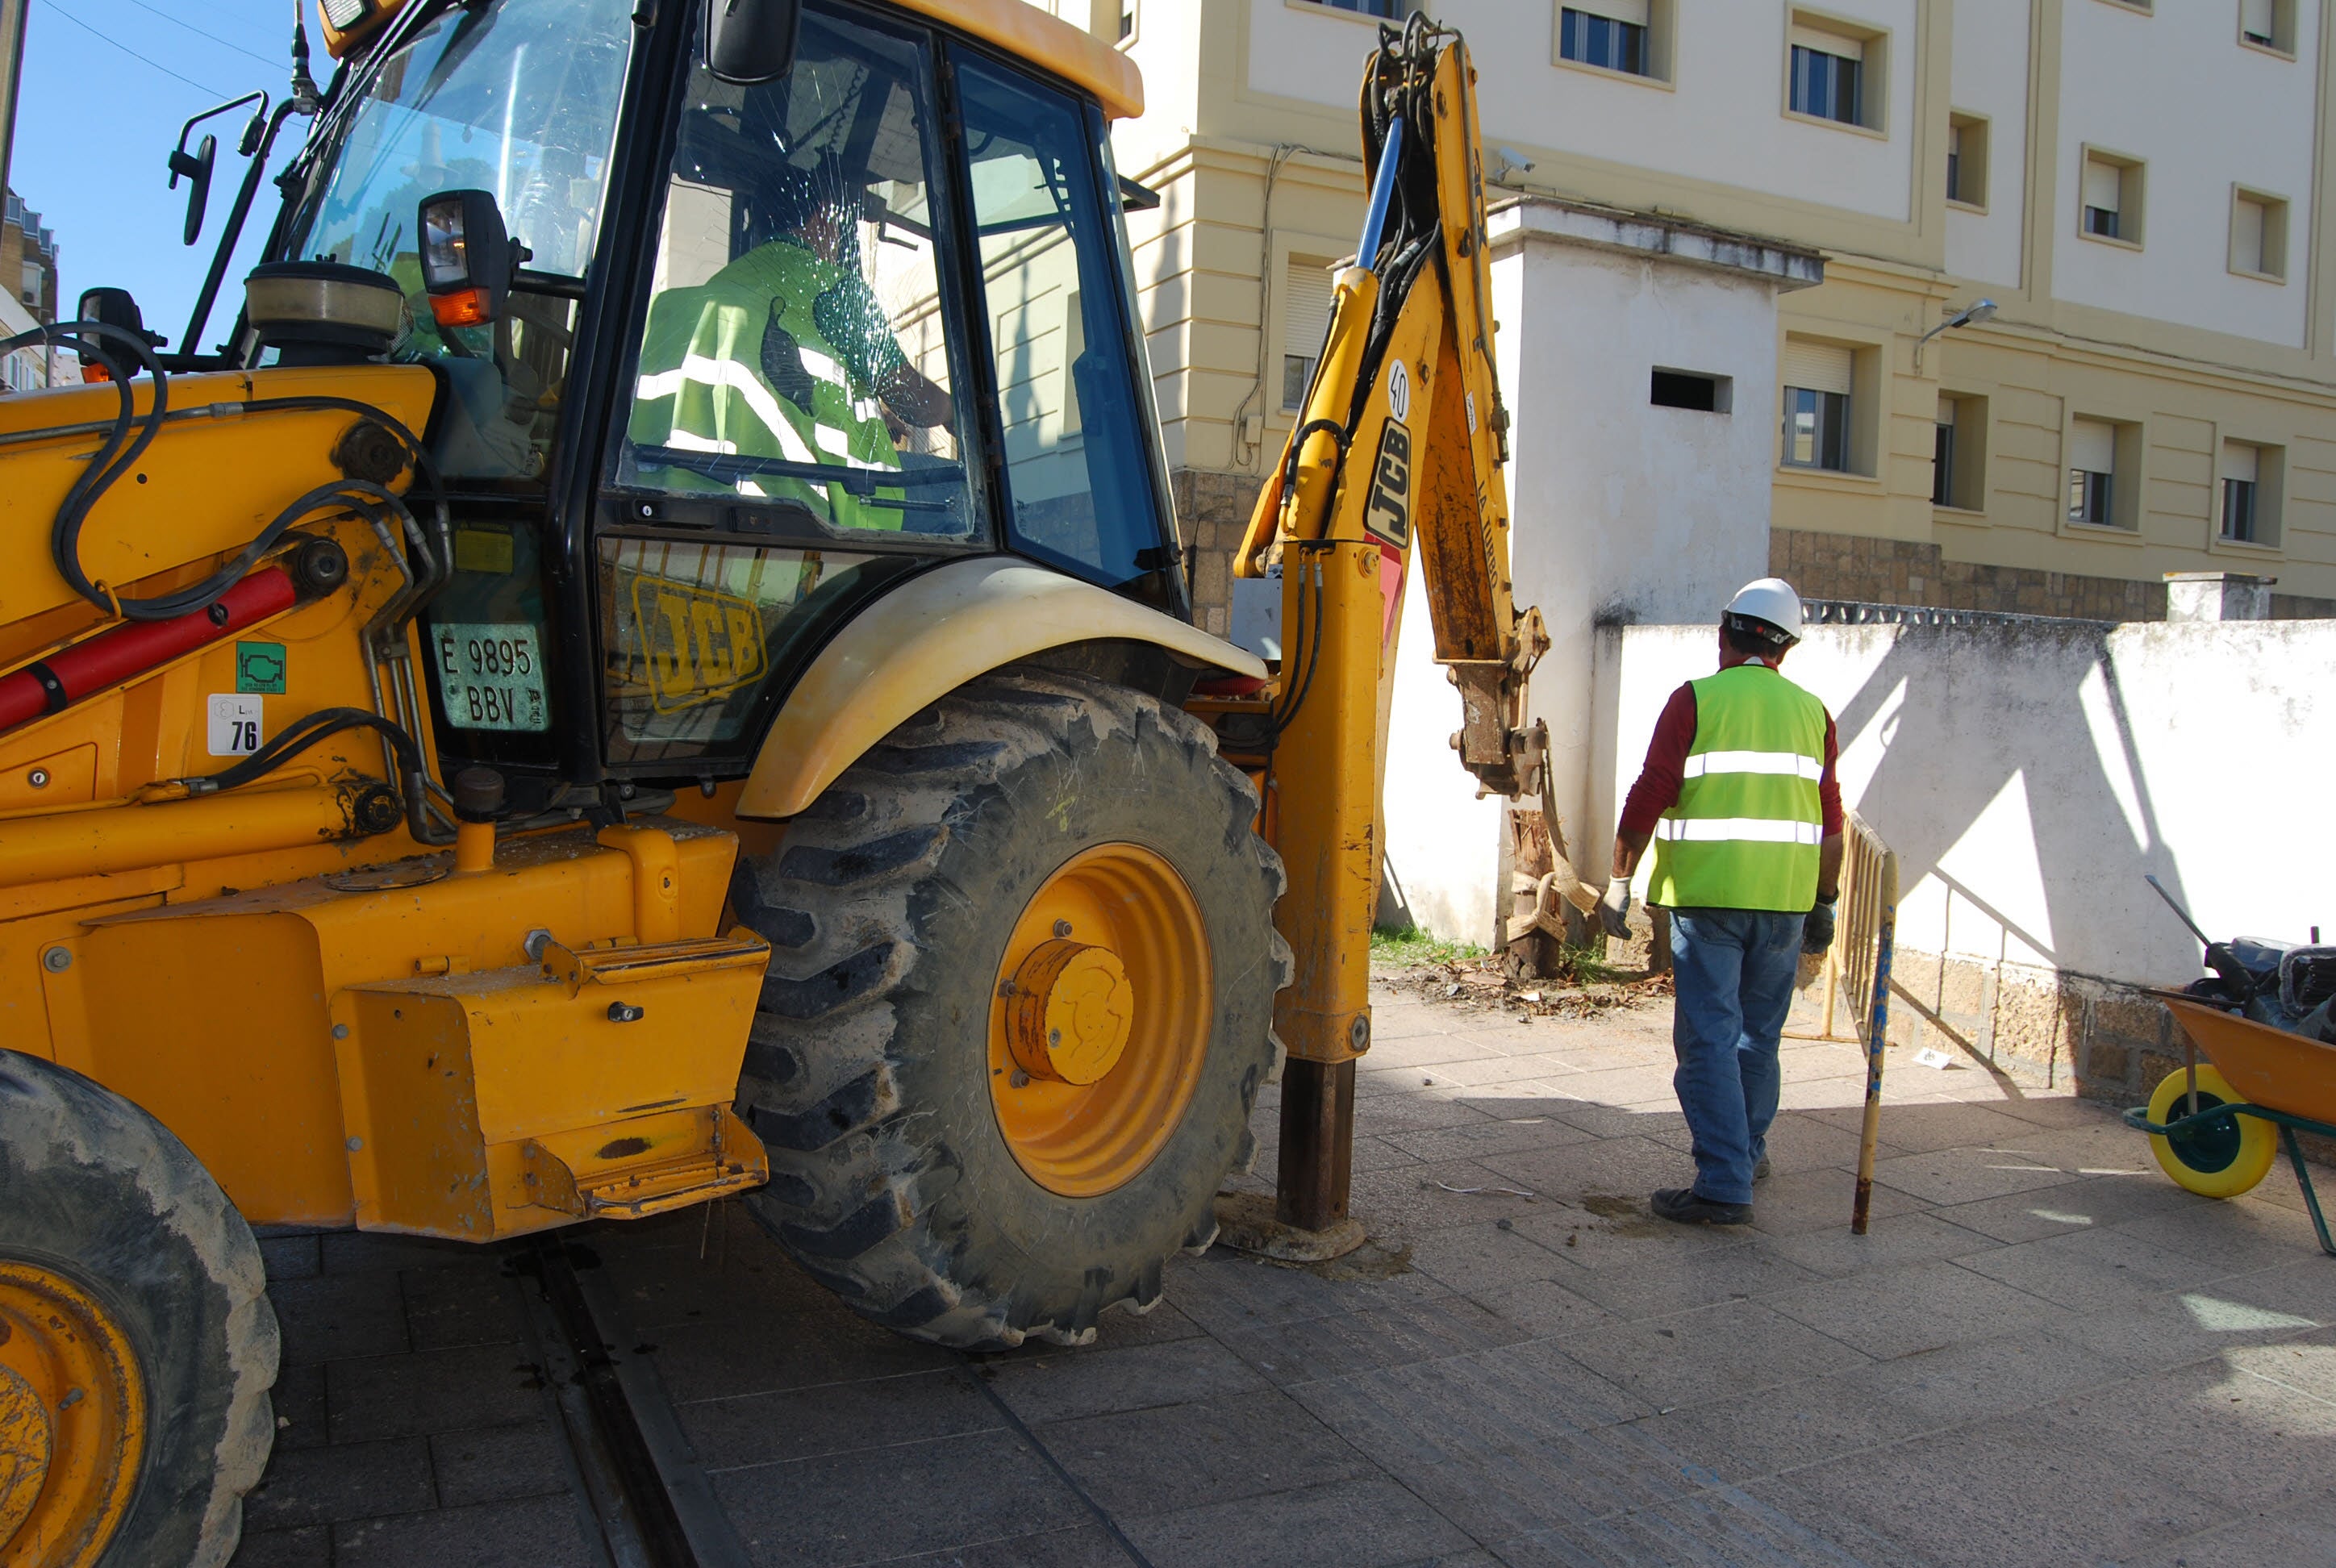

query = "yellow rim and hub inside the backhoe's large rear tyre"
[988,844,1215,1196]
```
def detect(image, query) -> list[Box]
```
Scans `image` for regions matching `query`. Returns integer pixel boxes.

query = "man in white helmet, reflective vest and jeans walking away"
[1600,578,1841,1224]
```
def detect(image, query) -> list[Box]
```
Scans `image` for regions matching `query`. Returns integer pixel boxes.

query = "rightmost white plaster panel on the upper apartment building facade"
[2055,0,2320,348]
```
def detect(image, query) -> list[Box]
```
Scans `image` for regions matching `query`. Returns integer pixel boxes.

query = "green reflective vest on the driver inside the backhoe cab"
[628,239,907,533]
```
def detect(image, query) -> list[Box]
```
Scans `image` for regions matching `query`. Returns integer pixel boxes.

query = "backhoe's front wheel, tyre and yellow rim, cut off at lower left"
[0,1052,276,1568]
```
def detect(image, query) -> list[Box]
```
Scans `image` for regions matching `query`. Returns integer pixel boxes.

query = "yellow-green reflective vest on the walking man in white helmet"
[1647,664,1825,914]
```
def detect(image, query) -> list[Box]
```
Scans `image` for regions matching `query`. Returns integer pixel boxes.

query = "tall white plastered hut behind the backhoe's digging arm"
[1385,215,1778,942]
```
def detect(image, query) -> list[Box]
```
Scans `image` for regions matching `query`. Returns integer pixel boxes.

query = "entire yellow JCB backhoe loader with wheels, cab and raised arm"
[0,0,1544,1568]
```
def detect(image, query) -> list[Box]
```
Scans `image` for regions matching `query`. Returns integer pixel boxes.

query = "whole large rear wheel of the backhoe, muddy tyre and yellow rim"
[733,669,1290,1349]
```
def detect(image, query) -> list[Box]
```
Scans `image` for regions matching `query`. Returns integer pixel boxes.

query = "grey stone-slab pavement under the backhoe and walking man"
[238,993,2336,1568]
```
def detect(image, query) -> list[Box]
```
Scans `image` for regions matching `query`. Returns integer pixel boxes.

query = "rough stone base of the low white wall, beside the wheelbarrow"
[1878,949,2336,1164]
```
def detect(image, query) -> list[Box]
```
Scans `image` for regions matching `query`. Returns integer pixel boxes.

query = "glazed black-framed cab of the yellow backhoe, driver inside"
[276,0,1184,808]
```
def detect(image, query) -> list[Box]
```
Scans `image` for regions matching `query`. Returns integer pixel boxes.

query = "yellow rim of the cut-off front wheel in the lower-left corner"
[0,1260,147,1568]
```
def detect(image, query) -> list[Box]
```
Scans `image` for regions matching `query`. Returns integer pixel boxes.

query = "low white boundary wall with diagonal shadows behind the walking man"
[1607,622,2336,984]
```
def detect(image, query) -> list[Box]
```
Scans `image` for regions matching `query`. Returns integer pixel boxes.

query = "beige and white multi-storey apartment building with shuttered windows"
[1042,0,2336,640]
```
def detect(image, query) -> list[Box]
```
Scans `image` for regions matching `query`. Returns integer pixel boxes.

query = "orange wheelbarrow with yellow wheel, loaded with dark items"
[2125,990,2336,1257]
